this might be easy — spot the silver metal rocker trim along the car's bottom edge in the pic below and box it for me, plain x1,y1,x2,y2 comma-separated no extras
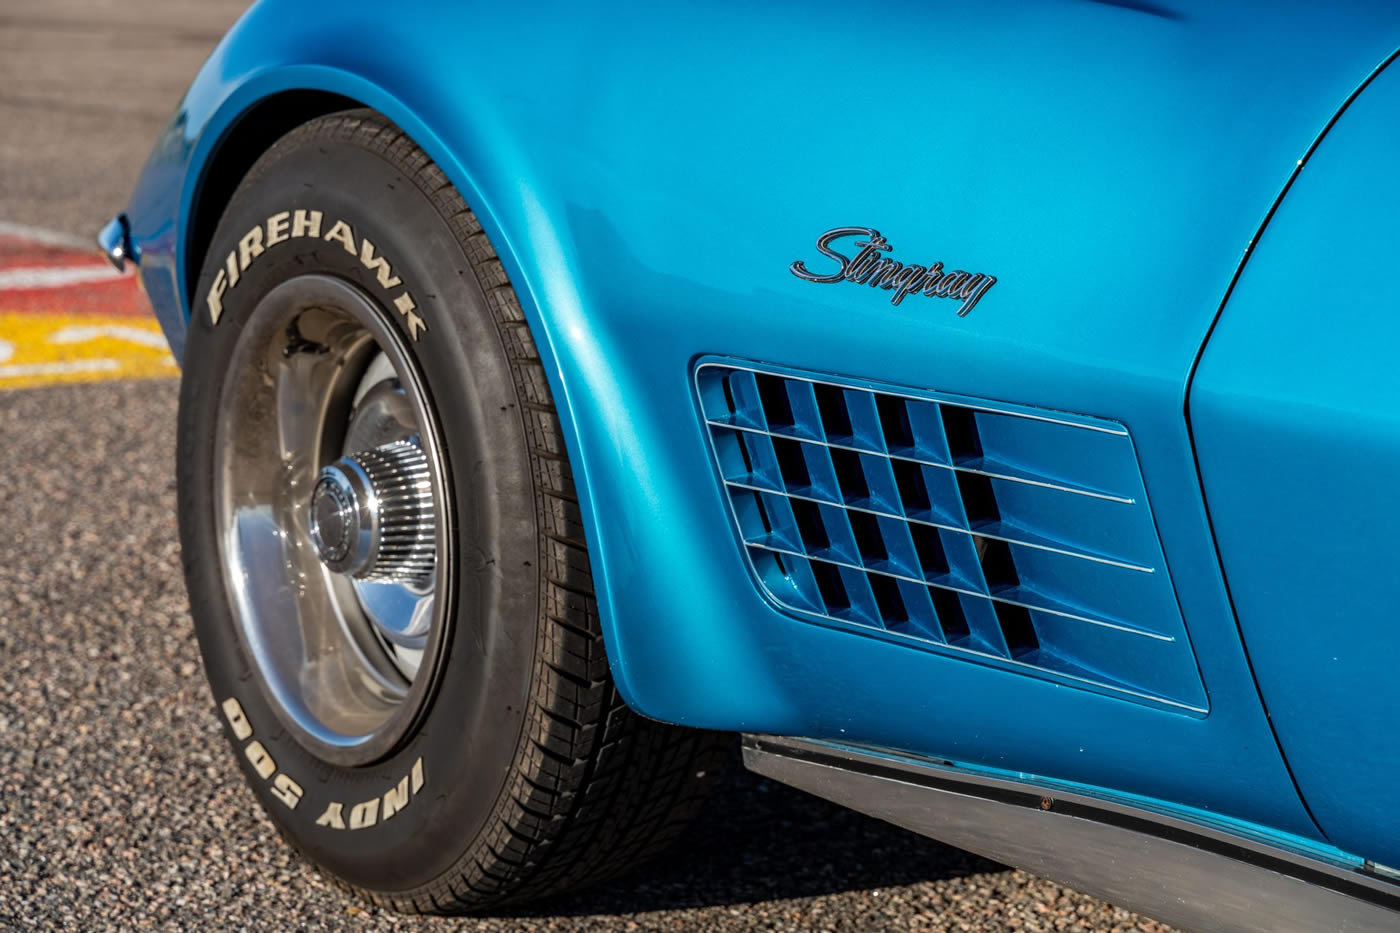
743,735,1400,933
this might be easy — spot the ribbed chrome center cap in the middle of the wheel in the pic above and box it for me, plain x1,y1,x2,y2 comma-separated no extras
308,441,435,584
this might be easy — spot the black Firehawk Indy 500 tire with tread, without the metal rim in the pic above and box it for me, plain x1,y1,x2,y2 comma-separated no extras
178,111,728,912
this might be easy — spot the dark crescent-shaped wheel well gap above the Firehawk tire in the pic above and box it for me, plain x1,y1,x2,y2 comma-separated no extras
185,91,364,307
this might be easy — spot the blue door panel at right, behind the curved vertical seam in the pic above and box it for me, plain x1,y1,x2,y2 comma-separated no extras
1190,49,1400,864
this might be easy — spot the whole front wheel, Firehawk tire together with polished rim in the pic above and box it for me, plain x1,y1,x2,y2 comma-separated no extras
179,111,724,912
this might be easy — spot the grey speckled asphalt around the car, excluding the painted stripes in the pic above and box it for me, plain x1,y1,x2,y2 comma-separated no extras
0,0,1166,933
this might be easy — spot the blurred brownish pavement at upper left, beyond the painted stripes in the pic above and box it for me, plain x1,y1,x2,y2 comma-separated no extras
0,0,248,237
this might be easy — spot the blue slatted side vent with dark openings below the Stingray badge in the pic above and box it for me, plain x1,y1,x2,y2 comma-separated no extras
696,361,1207,714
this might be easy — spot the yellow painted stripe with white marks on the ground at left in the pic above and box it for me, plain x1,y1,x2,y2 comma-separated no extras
0,314,179,389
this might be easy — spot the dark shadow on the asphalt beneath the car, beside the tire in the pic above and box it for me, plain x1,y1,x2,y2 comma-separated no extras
496,739,1007,918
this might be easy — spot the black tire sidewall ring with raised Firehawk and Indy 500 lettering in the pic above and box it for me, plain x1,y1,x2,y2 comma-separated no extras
178,121,539,891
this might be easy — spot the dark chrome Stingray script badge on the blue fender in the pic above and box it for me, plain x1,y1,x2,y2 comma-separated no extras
788,227,997,318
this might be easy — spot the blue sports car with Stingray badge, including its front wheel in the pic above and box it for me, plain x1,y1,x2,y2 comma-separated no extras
99,0,1400,930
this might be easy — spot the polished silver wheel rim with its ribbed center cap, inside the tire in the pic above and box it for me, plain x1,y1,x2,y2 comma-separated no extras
214,275,454,765
